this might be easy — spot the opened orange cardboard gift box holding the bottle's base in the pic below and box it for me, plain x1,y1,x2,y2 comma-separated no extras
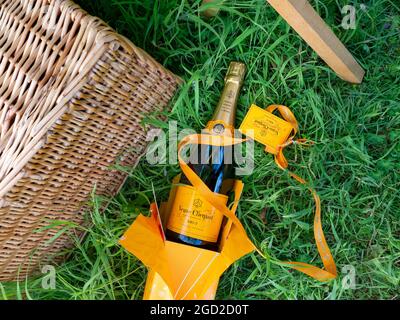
120,177,254,300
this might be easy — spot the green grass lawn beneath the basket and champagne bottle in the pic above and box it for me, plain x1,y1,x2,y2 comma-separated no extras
0,0,400,299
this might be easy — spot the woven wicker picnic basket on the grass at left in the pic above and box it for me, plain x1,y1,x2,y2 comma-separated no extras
0,0,179,281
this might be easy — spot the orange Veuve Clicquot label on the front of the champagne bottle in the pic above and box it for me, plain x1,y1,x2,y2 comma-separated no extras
167,186,228,242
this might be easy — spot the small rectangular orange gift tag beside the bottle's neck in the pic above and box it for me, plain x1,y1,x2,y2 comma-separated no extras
239,104,294,154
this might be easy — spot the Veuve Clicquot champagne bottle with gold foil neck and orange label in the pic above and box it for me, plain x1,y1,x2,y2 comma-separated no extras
166,62,246,249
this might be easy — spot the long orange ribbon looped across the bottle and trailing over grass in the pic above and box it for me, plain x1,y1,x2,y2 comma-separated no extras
178,111,337,281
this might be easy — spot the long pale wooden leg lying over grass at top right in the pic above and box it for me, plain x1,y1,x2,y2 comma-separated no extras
267,0,365,83
